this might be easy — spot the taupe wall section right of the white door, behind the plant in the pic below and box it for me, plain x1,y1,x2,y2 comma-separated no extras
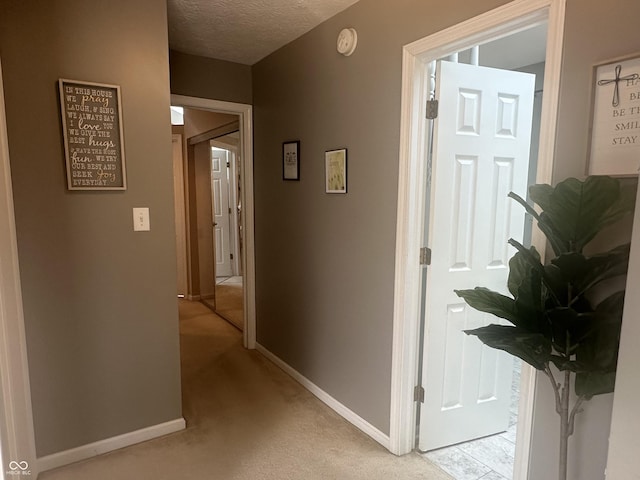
531,0,640,480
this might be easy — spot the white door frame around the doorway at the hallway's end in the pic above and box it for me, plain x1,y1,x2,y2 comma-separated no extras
171,95,256,349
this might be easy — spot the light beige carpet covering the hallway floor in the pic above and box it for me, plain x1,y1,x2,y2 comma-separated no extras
40,301,451,480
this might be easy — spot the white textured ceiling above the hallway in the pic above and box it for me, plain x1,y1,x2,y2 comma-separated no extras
167,0,358,65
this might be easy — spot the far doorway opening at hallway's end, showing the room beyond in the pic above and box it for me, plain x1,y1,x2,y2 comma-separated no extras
172,106,244,330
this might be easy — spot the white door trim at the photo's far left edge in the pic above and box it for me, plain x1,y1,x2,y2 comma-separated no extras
0,57,38,478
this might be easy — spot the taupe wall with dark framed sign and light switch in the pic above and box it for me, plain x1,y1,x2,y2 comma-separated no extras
0,0,181,456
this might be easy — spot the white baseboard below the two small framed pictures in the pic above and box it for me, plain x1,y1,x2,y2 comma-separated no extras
256,343,391,450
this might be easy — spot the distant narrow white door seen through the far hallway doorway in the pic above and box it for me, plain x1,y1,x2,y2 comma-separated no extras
211,147,232,277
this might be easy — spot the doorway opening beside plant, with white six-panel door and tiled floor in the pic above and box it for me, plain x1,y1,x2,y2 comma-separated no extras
417,27,547,480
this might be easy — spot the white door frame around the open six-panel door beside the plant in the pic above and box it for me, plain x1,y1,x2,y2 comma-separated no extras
389,0,565,479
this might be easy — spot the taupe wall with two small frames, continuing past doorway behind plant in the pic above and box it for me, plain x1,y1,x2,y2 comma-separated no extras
253,0,640,480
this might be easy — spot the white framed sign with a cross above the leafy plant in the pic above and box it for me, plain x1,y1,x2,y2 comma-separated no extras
588,57,640,176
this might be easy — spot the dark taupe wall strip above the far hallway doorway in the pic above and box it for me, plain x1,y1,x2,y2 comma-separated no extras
169,50,252,104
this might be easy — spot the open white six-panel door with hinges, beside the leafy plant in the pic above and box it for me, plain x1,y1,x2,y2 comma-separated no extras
418,62,535,451
